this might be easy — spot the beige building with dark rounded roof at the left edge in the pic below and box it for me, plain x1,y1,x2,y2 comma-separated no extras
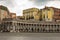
0,5,9,22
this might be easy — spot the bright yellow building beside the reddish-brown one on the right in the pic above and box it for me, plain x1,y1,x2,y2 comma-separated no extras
42,7,54,21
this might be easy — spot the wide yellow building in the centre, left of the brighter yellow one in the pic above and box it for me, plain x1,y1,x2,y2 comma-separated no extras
23,8,40,20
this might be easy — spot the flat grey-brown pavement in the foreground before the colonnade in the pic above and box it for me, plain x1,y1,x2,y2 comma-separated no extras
0,33,60,40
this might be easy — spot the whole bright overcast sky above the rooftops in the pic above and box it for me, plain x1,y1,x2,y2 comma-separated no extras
0,0,60,16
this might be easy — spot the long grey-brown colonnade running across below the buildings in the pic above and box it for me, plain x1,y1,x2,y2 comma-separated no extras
0,22,60,32
